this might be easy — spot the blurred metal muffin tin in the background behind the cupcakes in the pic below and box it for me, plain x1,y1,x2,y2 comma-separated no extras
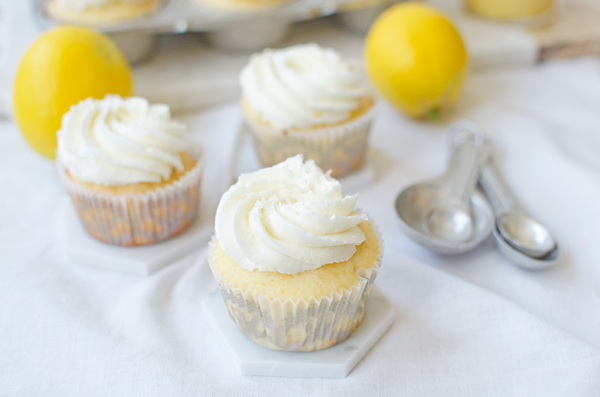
32,0,396,58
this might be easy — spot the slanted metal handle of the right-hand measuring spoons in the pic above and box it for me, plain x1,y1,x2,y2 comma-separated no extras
479,160,523,215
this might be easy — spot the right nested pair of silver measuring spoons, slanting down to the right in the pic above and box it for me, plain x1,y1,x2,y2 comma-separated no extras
479,161,560,269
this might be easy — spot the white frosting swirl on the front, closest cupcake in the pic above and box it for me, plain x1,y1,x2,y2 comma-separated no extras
215,155,367,274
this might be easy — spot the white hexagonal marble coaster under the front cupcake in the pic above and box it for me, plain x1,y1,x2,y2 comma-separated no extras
202,287,396,378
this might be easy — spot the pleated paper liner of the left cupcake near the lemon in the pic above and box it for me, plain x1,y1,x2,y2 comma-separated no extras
56,146,204,246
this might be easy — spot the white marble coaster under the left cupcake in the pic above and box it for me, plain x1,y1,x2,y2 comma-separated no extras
63,197,214,276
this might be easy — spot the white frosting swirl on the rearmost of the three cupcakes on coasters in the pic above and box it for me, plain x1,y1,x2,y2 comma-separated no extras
240,44,369,128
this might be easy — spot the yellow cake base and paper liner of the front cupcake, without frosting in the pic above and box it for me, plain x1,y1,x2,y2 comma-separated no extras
208,218,383,351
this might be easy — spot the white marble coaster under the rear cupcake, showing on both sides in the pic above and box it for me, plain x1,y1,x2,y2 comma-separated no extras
231,125,375,194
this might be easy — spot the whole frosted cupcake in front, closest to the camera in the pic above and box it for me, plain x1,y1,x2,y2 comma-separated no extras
208,155,383,351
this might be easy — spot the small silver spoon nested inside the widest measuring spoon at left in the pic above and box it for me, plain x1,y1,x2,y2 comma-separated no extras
425,122,488,243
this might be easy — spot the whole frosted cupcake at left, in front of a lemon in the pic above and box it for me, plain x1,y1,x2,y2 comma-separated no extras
57,95,202,246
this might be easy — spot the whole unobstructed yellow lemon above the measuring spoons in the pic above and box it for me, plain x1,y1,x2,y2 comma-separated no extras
365,2,468,118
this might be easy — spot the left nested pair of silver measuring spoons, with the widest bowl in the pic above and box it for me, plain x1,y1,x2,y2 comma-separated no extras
395,121,492,254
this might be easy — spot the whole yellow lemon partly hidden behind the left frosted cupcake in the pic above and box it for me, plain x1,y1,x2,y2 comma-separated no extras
13,26,133,158
